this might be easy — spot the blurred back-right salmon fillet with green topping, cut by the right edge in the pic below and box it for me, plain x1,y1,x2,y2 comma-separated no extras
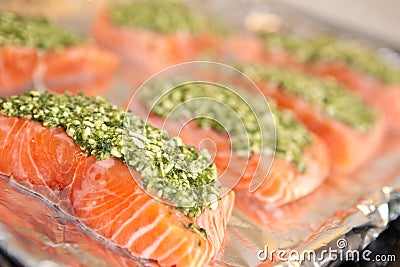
256,34,400,134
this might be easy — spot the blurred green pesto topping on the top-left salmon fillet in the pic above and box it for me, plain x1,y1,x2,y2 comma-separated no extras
0,11,84,50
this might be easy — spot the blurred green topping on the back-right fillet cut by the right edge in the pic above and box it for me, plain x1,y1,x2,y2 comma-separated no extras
264,34,400,84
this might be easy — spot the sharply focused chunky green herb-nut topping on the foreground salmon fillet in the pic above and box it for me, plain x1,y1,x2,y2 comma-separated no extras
0,91,219,217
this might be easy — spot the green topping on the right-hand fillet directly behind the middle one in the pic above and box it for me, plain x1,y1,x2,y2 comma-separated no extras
241,66,377,133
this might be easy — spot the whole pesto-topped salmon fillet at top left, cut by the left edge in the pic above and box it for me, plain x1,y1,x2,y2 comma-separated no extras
0,11,117,97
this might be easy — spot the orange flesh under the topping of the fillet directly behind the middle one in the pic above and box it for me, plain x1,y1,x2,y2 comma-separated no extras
259,82,386,173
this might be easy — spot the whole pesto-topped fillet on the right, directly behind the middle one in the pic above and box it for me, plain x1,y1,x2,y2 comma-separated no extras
242,65,386,174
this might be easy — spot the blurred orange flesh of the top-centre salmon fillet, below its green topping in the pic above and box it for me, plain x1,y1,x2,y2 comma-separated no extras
92,1,222,85
